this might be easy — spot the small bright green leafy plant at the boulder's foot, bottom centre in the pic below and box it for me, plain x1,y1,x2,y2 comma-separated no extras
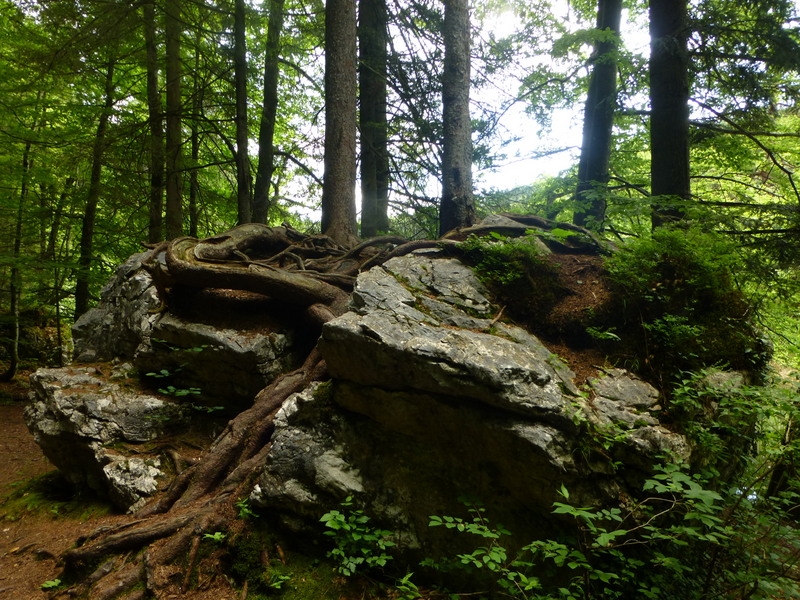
320,496,395,576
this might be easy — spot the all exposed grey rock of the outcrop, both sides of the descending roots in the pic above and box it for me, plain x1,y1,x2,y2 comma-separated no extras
27,243,689,540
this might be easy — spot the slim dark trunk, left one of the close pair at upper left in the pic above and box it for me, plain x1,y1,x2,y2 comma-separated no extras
142,2,164,243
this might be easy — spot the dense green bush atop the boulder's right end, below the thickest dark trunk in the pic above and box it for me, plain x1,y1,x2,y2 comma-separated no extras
606,228,770,383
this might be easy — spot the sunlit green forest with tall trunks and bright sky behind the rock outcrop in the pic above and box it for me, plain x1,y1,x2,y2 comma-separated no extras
0,0,800,598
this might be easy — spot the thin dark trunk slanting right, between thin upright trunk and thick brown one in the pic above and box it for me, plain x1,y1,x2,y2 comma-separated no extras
253,0,284,223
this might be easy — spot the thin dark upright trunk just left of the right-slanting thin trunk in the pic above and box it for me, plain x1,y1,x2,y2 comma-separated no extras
233,0,252,225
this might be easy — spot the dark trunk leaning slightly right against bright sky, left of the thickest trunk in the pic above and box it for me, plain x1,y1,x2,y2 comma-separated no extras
573,0,622,230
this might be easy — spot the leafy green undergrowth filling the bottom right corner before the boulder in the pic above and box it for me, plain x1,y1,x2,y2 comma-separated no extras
418,464,800,600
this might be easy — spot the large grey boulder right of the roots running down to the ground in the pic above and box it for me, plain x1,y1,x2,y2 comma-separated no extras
252,256,689,552
